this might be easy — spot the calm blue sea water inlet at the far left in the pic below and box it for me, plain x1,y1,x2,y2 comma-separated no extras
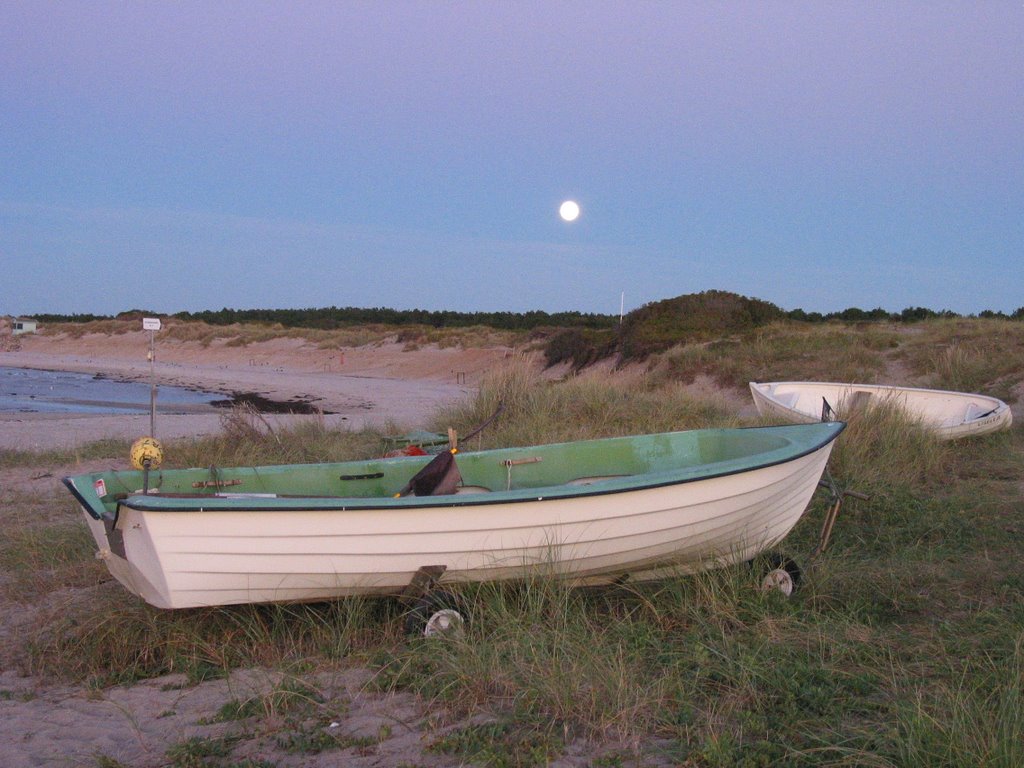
0,367,224,414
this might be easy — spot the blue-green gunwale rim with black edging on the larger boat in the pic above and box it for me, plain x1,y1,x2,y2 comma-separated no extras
79,421,846,519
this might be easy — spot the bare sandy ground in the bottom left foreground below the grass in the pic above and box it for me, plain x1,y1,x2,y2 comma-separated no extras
0,670,452,768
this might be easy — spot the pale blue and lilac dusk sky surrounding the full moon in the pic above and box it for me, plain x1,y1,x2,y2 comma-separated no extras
0,0,1024,314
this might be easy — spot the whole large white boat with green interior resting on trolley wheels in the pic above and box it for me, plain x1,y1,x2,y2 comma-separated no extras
65,422,845,608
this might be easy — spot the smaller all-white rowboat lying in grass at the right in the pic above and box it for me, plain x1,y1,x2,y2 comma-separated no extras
751,381,1013,440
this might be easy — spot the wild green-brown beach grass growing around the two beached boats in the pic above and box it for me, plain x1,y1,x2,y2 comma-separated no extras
0,321,1024,768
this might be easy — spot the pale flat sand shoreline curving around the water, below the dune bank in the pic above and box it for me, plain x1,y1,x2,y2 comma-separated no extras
0,348,487,451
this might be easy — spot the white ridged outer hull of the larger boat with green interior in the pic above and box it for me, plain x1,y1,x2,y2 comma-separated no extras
66,424,843,608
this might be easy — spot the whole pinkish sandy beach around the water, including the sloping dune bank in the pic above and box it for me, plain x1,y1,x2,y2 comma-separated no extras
0,332,512,450
